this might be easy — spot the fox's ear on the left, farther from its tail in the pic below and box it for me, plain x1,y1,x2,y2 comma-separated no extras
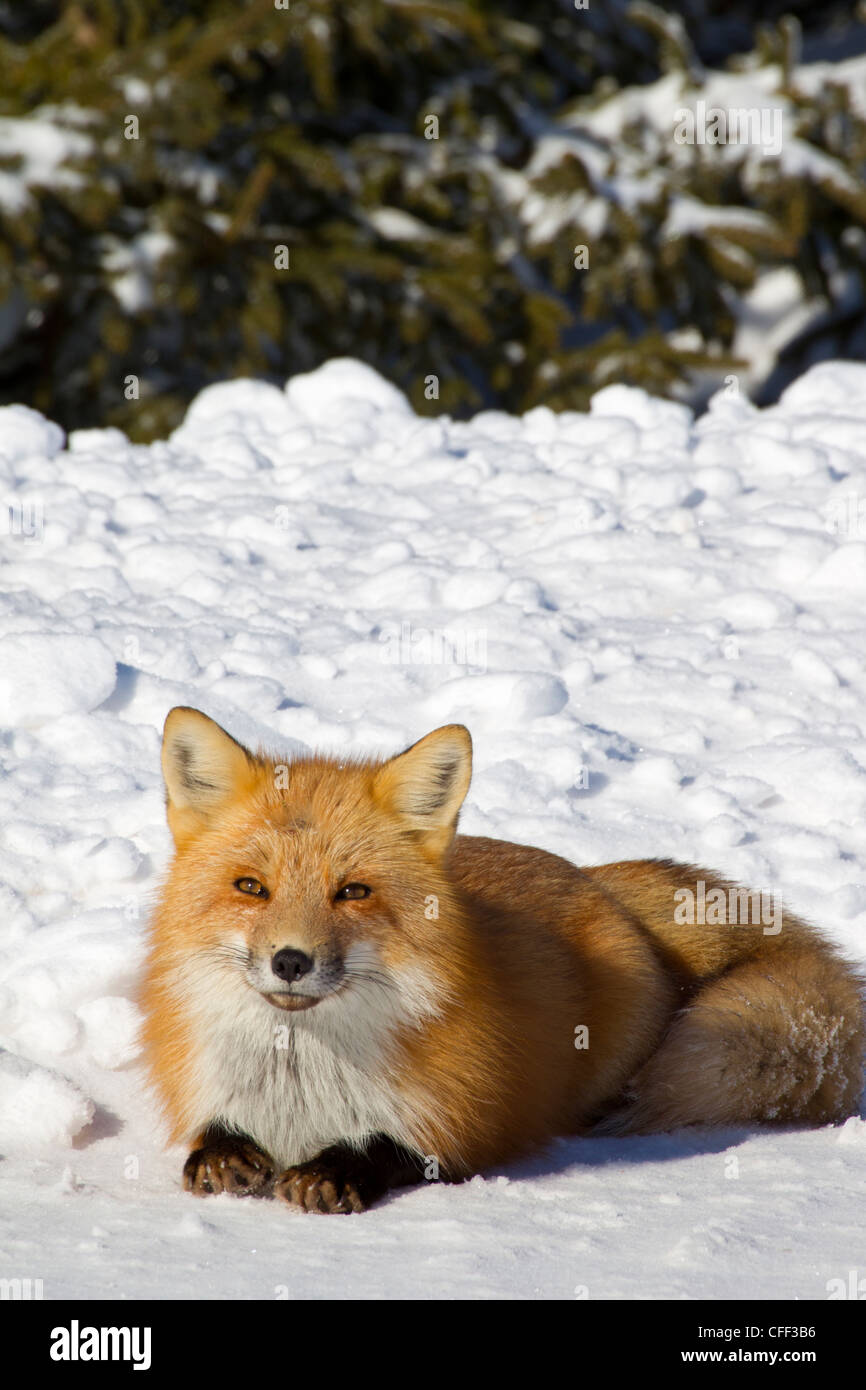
163,705,256,847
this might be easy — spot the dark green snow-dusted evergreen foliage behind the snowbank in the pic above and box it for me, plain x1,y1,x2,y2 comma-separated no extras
0,0,866,438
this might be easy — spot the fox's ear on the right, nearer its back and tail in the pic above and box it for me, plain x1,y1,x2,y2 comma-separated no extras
374,724,473,855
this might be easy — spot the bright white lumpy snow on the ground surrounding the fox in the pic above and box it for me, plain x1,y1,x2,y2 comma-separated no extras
0,360,866,1298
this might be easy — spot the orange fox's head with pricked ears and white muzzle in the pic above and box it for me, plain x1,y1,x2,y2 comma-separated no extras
157,708,471,1015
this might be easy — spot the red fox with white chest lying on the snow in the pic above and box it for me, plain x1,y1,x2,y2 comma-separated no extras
142,708,865,1212
